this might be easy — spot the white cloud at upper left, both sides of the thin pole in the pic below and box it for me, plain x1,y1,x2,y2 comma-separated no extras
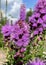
1,0,22,20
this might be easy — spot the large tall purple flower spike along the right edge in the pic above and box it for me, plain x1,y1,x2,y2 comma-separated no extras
29,0,46,35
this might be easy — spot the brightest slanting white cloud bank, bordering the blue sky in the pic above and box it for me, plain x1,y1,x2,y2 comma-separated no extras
8,0,22,18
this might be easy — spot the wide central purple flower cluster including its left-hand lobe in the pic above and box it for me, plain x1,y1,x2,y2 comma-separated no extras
2,20,30,47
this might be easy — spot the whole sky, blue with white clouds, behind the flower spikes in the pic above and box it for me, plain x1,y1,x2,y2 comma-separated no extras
1,0,37,20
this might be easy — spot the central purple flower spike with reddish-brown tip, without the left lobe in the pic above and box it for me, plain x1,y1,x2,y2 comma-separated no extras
12,20,30,47
